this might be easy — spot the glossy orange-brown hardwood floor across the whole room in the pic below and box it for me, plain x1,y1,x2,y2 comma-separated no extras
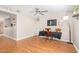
0,36,76,53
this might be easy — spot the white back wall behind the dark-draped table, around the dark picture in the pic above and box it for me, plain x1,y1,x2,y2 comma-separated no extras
38,12,70,41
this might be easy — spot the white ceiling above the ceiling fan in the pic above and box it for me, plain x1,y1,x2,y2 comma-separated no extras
0,5,72,14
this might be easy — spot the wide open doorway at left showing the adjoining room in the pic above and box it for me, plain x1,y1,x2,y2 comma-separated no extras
0,11,17,39
